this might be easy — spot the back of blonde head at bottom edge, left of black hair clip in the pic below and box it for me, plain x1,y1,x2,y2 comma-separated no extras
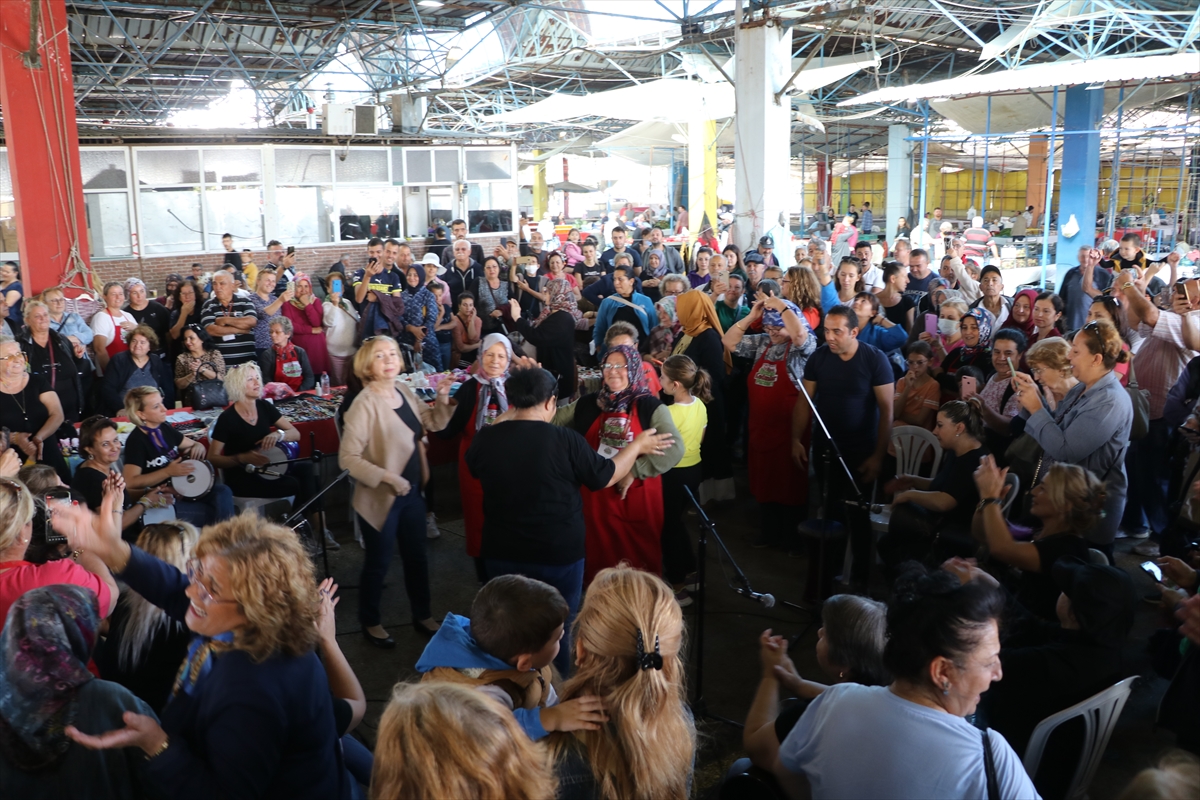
371,684,554,800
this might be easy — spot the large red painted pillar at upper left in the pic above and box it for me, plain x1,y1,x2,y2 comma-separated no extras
0,0,90,294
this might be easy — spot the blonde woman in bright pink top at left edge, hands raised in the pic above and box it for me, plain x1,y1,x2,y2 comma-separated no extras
0,477,121,620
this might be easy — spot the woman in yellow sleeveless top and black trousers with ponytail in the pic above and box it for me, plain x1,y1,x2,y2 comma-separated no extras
659,357,713,606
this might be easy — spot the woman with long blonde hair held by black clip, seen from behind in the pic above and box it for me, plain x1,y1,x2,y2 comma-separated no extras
550,565,696,800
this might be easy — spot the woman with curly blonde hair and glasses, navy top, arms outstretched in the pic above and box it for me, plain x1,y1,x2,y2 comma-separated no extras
53,504,349,800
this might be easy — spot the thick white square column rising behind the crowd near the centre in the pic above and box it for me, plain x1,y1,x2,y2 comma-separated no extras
734,19,792,249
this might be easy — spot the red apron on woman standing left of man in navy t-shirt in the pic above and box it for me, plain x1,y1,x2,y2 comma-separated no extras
746,345,811,506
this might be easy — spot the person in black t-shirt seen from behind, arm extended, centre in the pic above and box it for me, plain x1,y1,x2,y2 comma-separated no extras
467,367,672,669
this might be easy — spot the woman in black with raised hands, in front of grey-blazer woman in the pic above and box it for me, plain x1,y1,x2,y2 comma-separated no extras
974,457,1106,621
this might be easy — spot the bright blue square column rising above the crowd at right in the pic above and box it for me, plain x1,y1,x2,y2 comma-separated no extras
1055,86,1104,256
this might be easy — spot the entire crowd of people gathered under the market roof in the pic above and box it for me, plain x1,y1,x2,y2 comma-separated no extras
0,209,1200,798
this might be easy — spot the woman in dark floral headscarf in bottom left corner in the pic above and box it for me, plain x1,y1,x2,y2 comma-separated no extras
0,584,155,799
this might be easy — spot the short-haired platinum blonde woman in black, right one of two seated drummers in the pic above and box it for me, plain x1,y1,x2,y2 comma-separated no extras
209,363,325,536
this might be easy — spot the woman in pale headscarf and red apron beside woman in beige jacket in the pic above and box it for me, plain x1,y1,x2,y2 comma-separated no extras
438,333,514,583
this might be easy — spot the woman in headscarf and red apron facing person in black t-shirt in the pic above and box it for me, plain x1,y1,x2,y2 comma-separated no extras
554,344,684,587
